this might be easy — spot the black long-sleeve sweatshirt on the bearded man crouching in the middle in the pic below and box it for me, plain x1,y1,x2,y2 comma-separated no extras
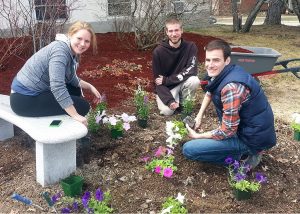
152,39,198,106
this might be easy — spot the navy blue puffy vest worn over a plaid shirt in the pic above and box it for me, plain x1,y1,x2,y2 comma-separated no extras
206,65,276,153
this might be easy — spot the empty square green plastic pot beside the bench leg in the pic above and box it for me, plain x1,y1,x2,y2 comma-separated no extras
60,175,83,197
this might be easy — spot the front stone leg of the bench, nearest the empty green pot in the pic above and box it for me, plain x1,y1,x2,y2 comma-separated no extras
36,140,76,187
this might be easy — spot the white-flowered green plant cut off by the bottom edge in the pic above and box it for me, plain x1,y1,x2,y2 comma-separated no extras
161,193,188,214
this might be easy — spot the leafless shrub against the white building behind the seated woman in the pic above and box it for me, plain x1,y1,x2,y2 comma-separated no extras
0,0,78,52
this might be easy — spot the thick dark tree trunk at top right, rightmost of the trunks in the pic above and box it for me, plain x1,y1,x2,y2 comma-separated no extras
264,0,284,25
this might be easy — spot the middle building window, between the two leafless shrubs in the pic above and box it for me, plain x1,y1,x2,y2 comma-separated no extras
107,0,131,16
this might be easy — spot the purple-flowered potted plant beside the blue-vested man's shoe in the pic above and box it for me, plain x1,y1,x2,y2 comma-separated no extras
225,157,267,192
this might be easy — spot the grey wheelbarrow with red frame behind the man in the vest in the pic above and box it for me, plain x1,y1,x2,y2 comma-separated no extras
200,46,300,89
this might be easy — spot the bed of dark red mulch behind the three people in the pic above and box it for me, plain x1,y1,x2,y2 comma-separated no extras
0,33,214,107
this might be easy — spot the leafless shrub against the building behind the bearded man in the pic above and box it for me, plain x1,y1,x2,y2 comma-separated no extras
97,0,210,50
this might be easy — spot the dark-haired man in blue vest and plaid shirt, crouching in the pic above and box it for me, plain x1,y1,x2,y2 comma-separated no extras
183,40,276,168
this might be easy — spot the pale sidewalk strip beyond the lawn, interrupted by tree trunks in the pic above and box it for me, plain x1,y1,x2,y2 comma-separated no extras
215,15,300,26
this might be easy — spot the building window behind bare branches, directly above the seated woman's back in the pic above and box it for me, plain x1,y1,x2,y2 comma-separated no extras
34,0,68,21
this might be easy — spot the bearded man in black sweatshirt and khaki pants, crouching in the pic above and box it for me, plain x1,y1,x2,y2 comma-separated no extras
152,19,200,115
